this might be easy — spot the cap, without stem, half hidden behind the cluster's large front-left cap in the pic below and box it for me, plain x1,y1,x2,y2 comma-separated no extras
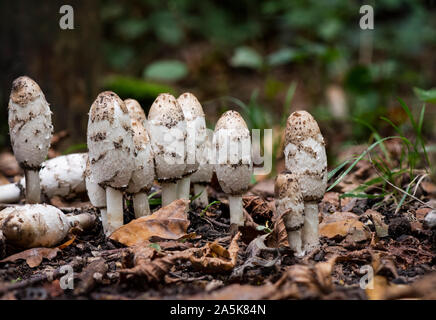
124,99,155,193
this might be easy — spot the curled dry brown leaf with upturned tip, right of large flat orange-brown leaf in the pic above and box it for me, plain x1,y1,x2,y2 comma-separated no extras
189,232,241,273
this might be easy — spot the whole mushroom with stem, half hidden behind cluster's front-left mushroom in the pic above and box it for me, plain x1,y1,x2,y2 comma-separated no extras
124,99,155,218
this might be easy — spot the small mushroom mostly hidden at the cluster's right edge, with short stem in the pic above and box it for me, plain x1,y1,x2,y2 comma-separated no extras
191,129,214,208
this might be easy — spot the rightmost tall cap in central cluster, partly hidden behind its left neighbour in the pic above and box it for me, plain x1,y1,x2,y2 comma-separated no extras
177,92,206,174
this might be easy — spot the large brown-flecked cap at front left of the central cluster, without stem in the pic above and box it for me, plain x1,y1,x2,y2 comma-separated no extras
87,91,135,189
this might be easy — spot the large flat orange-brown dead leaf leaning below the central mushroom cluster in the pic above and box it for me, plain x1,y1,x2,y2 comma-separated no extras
110,199,189,246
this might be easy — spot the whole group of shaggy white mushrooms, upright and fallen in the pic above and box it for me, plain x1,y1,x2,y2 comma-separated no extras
0,76,327,256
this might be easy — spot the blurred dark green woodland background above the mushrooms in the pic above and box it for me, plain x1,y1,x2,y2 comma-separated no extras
0,0,436,175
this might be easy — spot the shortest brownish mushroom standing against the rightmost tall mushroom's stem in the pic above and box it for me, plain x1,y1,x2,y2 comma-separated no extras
274,171,304,257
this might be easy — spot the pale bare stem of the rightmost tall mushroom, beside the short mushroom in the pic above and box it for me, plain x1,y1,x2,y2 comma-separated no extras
302,202,319,252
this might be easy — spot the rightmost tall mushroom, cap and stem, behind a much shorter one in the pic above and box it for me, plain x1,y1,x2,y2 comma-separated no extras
284,111,327,253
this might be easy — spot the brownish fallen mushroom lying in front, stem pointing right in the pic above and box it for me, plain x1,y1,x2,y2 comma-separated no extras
0,204,95,248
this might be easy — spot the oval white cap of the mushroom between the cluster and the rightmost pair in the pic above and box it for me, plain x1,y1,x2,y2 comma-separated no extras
213,110,253,195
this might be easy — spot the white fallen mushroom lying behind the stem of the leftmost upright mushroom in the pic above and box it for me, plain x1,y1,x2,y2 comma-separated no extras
0,153,88,203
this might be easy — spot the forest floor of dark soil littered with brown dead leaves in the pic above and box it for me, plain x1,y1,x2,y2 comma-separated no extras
0,140,436,300
